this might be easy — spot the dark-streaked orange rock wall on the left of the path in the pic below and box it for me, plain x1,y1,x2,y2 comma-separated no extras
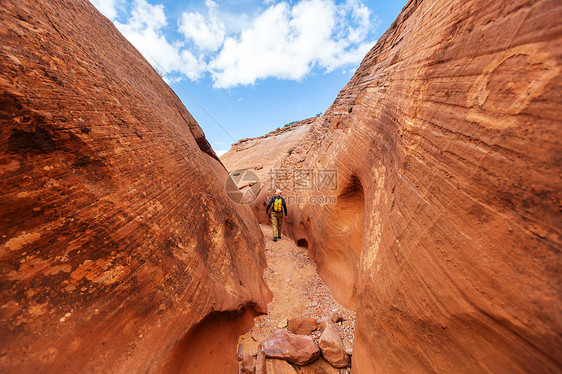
0,0,270,373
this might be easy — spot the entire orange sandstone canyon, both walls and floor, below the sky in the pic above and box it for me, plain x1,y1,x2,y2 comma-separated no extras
0,0,562,374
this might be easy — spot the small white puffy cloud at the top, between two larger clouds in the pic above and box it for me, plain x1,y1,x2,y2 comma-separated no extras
178,0,226,51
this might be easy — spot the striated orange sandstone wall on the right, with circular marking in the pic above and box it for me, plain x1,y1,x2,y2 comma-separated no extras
223,0,562,374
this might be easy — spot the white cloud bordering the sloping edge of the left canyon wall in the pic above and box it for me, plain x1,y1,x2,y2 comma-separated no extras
114,0,206,80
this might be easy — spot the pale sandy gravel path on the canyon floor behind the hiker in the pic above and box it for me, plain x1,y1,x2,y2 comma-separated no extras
239,225,355,353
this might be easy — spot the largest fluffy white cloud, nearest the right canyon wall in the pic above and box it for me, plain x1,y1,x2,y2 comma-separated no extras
209,0,373,88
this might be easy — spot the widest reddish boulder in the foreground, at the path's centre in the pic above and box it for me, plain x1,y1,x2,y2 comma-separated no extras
260,330,320,365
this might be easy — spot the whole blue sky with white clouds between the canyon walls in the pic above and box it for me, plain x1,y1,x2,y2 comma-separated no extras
90,0,407,154
